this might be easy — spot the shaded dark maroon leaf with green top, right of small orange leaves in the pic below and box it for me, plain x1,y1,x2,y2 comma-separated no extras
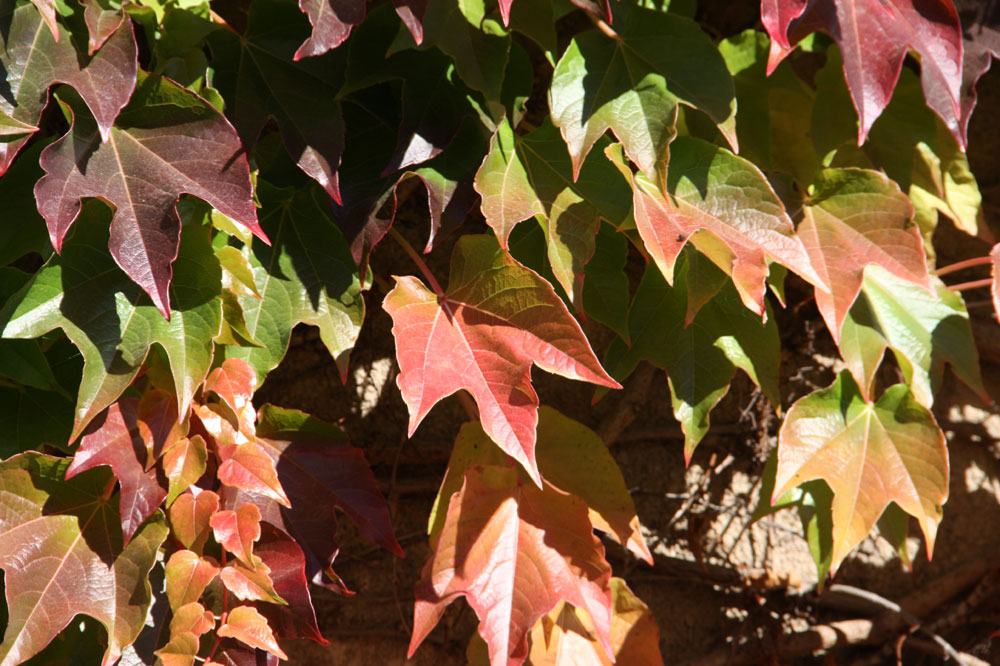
257,405,403,584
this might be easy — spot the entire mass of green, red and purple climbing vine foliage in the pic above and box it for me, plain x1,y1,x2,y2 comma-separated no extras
0,0,1000,666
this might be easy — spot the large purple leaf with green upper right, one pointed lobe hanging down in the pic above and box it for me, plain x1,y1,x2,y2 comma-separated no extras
35,70,267,318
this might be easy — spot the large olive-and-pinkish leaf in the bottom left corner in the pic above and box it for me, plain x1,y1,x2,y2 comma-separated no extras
0,452,167,666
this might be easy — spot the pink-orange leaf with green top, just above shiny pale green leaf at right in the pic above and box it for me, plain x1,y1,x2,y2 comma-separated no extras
798,169,933,341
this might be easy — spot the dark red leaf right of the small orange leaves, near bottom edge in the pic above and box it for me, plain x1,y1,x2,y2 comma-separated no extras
256,523,329,645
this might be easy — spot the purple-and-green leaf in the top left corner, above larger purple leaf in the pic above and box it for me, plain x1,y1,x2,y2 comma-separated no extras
0,2,138,175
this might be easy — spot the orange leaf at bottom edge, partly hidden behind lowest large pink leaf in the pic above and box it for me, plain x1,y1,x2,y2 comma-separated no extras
528,578,663,666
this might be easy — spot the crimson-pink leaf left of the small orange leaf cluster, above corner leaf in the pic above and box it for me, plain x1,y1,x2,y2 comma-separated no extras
66,399,167,545
